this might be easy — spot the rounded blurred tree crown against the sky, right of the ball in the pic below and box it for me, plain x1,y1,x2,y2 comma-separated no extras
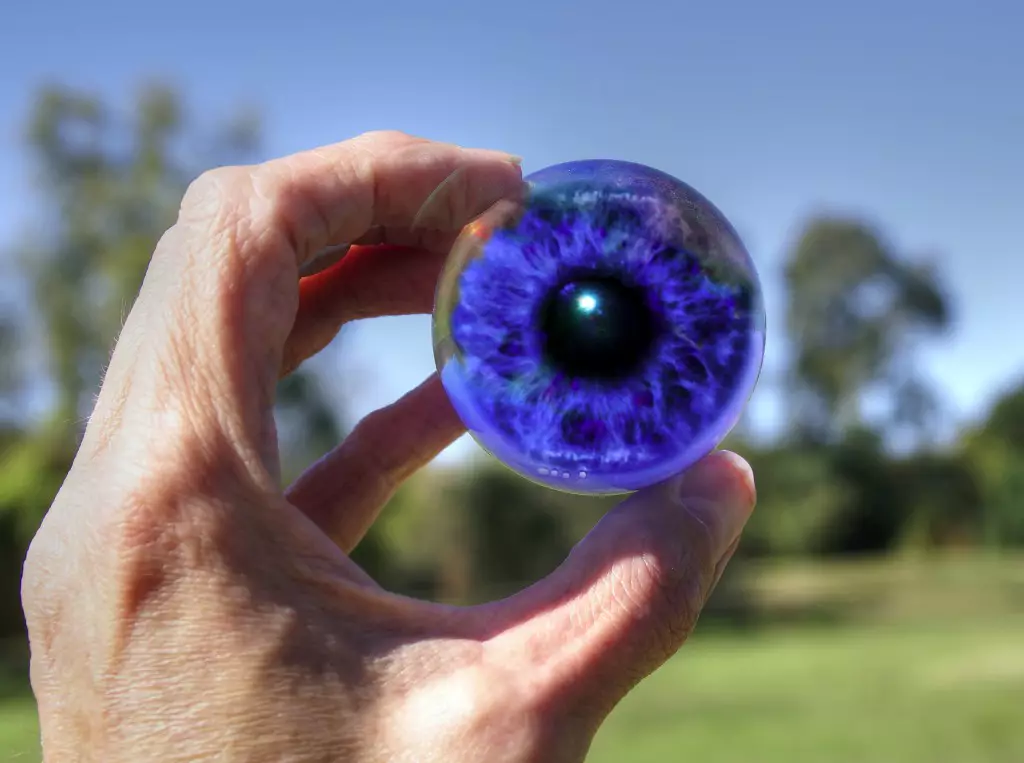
785,217,950,442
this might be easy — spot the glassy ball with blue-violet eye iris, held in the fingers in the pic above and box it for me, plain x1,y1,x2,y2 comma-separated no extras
433,161,765,494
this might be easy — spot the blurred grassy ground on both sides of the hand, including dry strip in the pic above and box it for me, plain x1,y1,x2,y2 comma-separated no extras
0,559,1024,763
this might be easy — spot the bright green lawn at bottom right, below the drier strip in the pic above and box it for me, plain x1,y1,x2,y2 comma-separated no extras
588,620,1024,763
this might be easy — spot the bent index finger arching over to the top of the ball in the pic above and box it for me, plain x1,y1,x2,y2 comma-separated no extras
87,132,522,461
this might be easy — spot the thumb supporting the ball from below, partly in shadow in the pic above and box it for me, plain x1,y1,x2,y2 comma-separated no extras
491,451,756,718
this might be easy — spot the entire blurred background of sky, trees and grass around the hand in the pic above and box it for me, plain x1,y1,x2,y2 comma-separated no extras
0,0,1024,763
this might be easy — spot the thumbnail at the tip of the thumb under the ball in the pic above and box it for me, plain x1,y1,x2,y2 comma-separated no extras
676,451,757,559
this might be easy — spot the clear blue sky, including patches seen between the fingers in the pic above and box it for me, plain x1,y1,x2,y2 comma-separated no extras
0,0,1024,458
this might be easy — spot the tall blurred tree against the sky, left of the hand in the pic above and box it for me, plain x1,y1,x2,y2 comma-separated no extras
22,84,258,432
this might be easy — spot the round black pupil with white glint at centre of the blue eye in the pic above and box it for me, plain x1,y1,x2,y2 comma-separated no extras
540,278,656,379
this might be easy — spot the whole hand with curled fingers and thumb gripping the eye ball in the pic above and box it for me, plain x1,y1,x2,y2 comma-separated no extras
23,133,754,763
